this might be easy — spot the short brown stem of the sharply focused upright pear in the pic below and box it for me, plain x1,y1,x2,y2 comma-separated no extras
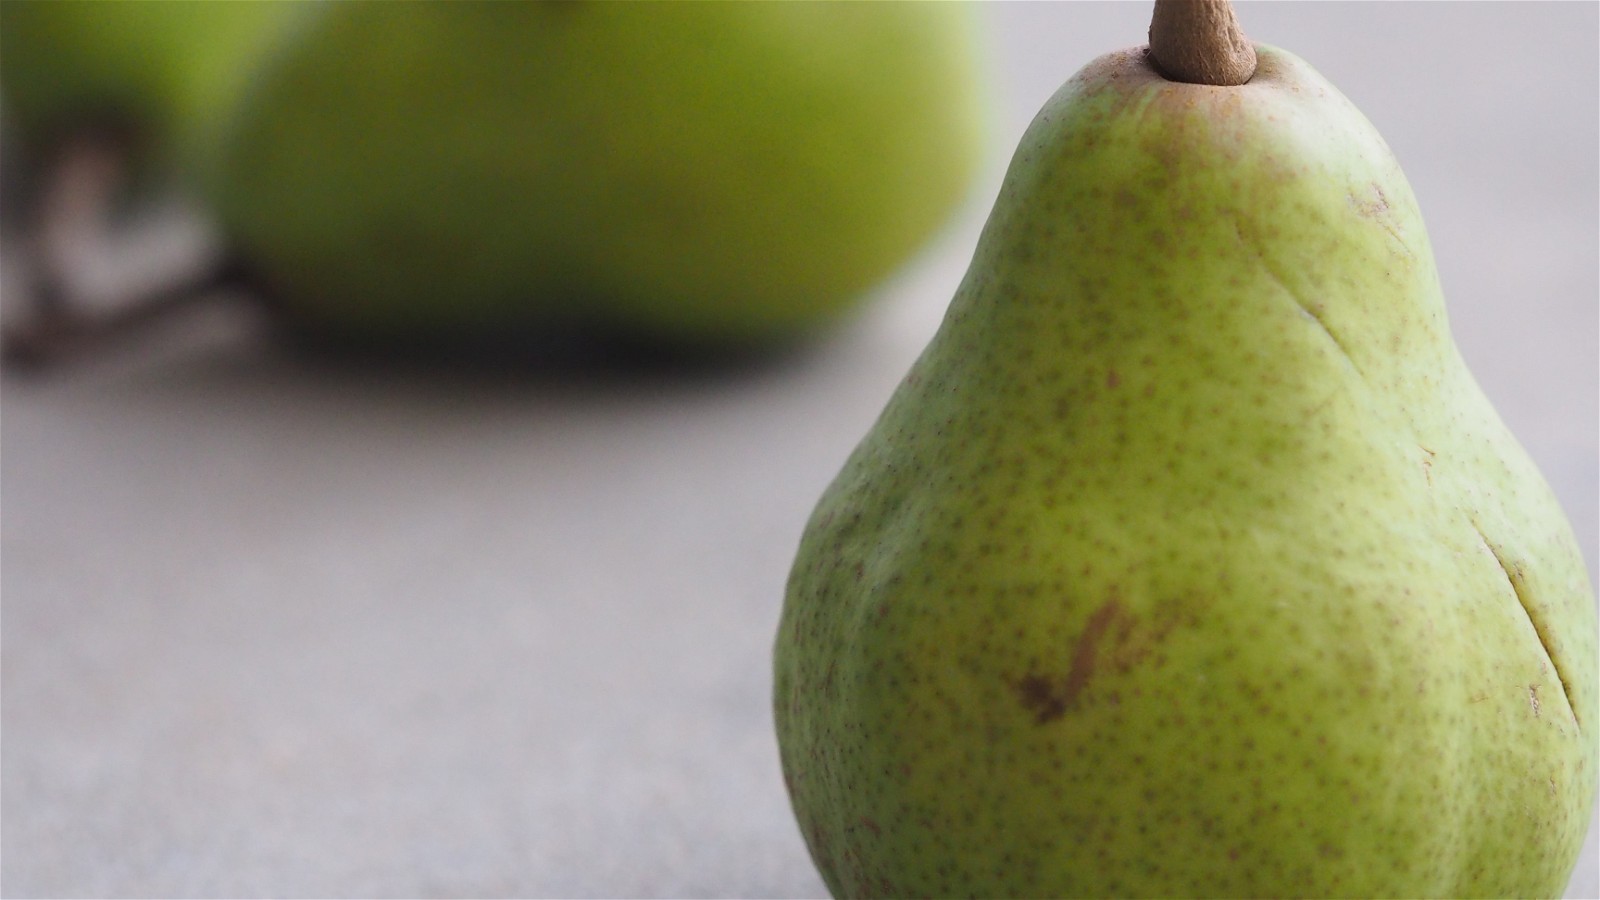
1150,0,1256,86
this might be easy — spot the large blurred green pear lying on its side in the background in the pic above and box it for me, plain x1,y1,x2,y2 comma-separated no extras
208,3,986,344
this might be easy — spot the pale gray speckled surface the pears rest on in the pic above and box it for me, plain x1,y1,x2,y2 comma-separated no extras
0,3,1600,897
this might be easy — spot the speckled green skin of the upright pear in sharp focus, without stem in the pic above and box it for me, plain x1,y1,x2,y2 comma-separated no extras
774,45,1597,897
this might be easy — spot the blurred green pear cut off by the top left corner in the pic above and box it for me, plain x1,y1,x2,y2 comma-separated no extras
0,0,302,171
